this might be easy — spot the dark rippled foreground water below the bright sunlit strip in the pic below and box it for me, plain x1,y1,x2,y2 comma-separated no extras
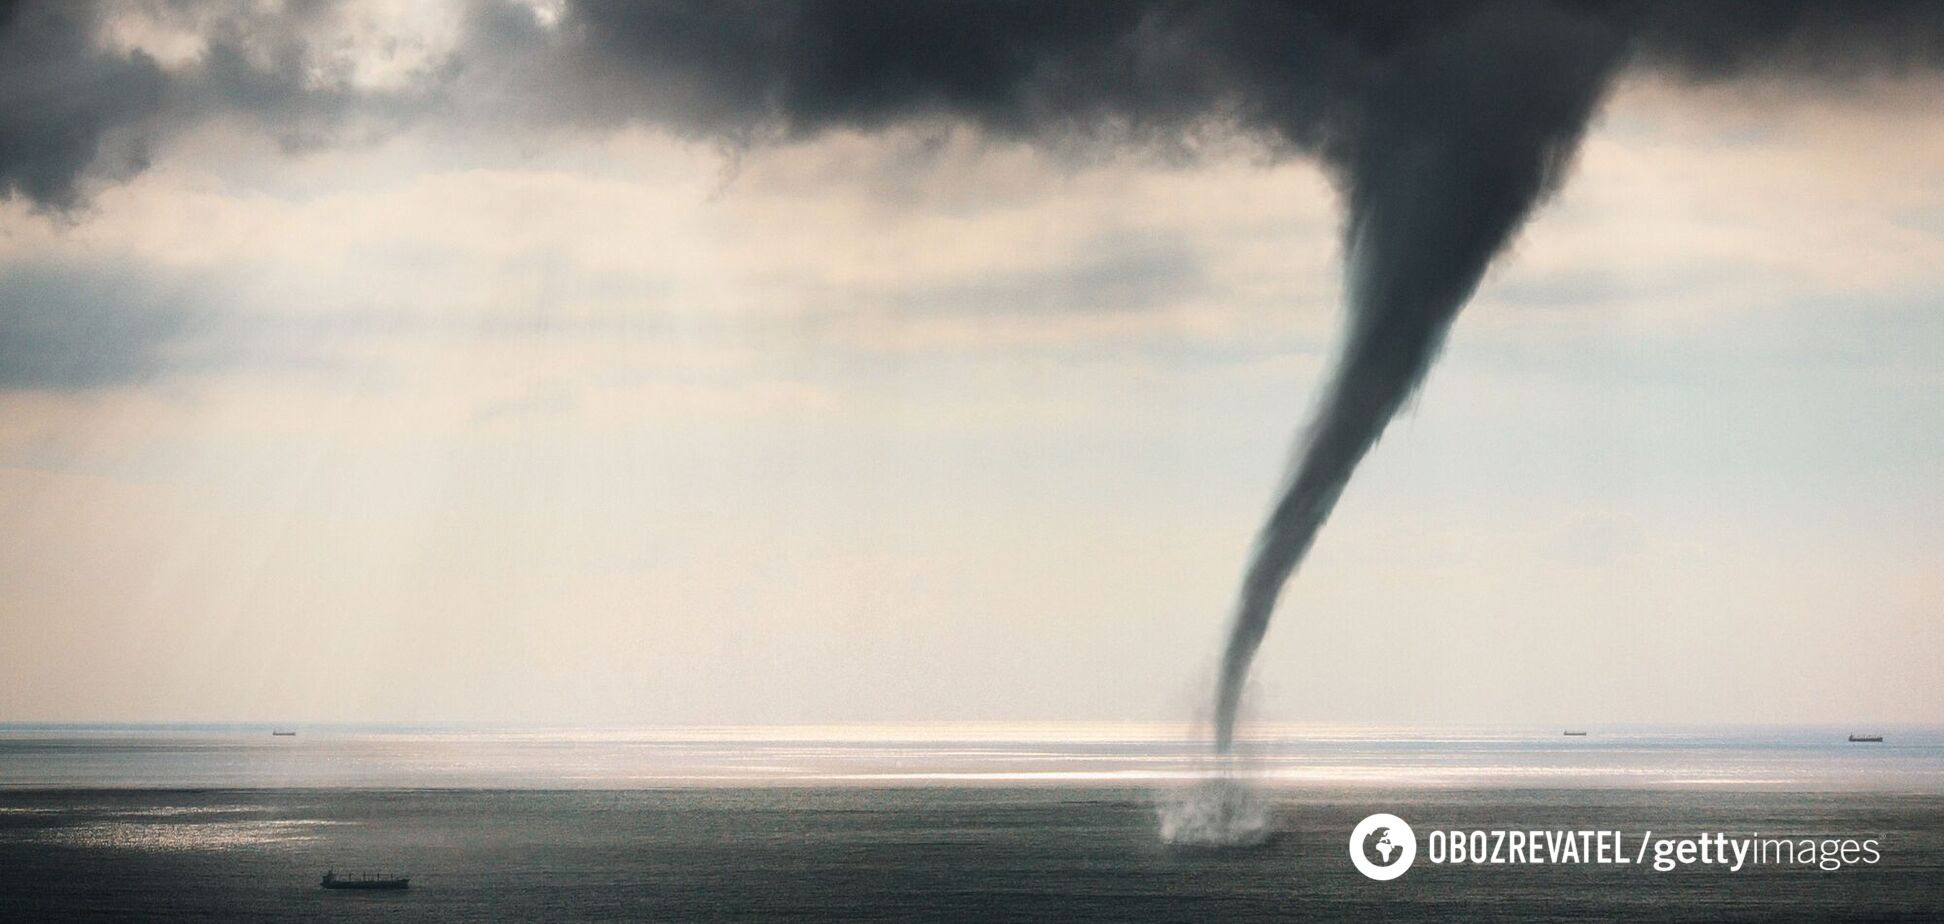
0,786,1944,922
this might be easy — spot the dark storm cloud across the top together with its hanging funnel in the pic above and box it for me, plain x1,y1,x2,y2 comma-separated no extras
11,0,1944,749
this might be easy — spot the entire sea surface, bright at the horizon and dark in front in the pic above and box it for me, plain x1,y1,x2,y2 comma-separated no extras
0,726,1944,922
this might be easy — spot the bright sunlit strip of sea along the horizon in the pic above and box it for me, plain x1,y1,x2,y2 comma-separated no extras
0,726,1944,793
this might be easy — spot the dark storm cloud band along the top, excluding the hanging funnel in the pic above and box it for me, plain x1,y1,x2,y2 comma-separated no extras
11,0,1944,210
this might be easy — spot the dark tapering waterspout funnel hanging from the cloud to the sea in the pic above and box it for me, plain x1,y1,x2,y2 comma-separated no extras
1215,8,1619,749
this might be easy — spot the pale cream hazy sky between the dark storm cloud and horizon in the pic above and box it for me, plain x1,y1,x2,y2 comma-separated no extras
0,4,1944,726
